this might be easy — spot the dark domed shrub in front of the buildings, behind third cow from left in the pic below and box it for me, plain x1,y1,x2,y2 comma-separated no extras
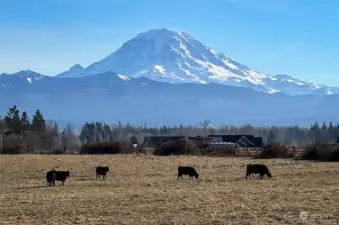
154,140,200,156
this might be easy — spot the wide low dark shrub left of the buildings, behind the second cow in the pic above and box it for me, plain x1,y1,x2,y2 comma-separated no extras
80,141,122,154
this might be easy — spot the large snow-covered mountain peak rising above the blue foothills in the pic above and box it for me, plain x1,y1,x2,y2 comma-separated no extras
57,28,339,95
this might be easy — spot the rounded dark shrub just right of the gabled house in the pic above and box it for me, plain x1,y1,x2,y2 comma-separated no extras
256,142,289,159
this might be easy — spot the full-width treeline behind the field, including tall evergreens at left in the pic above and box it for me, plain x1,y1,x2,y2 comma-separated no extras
0,106,339,155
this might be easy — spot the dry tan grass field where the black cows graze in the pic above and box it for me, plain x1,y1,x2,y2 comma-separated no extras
0,155,339,225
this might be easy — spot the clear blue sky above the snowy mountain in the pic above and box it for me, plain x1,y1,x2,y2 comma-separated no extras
0,0,339,86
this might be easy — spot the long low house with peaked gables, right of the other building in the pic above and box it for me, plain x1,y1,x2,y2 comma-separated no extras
208,134,264,148
